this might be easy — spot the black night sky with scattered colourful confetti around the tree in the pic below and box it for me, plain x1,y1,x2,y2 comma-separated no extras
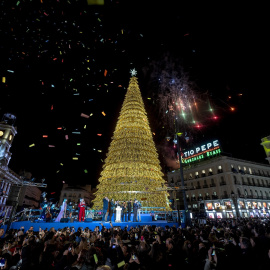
0,0,270,200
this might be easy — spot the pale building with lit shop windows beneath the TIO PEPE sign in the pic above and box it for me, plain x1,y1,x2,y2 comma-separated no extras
167,156,270,218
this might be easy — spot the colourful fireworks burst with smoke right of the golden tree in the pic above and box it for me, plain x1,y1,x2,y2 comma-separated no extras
144,53,218,168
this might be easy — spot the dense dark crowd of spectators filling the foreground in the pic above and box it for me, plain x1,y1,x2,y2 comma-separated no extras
0,218,270,270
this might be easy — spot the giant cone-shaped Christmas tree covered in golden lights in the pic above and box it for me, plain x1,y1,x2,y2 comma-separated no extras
93,77,170,210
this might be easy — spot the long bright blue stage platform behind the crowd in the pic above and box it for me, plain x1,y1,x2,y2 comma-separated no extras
10,220,179,231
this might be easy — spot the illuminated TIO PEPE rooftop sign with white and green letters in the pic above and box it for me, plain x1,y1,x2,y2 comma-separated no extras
182,140,221,163
